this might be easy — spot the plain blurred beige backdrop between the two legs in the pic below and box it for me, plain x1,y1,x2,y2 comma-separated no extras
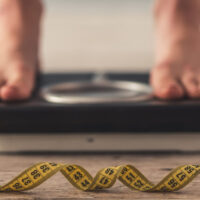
41,0,154,72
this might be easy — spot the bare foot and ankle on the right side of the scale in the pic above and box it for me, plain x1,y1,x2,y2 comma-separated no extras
151,0,200,99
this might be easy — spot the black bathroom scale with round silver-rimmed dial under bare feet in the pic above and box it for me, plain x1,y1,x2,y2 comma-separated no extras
0,73,200,152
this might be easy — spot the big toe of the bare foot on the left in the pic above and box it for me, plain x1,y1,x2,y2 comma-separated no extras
0,64,34,101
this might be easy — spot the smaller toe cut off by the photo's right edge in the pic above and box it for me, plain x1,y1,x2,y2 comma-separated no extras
182,74,200,99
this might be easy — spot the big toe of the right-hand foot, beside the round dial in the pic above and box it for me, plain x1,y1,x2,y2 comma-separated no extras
151,65,184,100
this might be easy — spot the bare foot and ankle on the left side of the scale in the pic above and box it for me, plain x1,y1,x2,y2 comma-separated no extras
0,0,42,101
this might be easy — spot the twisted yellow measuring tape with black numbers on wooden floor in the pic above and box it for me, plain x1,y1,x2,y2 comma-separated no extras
0,162,200,192
